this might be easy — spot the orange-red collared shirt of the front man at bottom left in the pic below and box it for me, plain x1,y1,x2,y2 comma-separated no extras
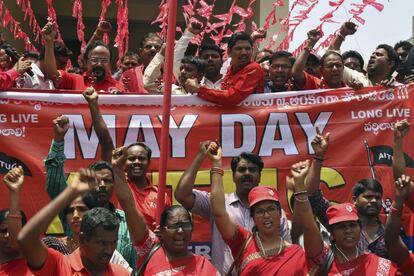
31,248,131,276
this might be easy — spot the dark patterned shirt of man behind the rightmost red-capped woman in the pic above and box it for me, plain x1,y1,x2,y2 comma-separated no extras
309,190,387,257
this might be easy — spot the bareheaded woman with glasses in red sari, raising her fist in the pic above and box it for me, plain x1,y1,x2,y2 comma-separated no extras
112,147,219,276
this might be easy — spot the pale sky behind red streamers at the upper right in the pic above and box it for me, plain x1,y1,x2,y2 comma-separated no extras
288,0,414,62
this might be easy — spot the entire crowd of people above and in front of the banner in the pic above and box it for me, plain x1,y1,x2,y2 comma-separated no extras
0,15,414,276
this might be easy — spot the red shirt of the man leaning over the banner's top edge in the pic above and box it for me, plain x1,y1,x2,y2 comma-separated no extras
198,62,264,106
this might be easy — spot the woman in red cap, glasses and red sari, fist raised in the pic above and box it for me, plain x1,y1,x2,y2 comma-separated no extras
208,142,308,275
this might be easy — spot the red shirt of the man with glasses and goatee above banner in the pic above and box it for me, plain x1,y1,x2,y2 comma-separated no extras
56,70,125,92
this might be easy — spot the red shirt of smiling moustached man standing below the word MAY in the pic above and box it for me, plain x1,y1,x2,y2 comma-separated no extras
113,177,171,231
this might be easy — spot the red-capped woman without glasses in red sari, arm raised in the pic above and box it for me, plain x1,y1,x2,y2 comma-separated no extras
291,161,400,276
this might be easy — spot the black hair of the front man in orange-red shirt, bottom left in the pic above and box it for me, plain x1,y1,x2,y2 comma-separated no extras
80,207,119,239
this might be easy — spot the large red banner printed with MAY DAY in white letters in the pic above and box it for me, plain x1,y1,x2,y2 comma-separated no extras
0,86,414,254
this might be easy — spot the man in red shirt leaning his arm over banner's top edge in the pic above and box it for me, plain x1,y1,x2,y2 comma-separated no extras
185,32,264,106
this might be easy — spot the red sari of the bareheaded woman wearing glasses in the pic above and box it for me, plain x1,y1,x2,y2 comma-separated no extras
135,231,220,276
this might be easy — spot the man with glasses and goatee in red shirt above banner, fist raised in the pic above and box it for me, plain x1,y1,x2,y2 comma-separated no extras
42,22,124,94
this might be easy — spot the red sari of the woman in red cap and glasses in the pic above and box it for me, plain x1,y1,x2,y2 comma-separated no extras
225,225,309,275
